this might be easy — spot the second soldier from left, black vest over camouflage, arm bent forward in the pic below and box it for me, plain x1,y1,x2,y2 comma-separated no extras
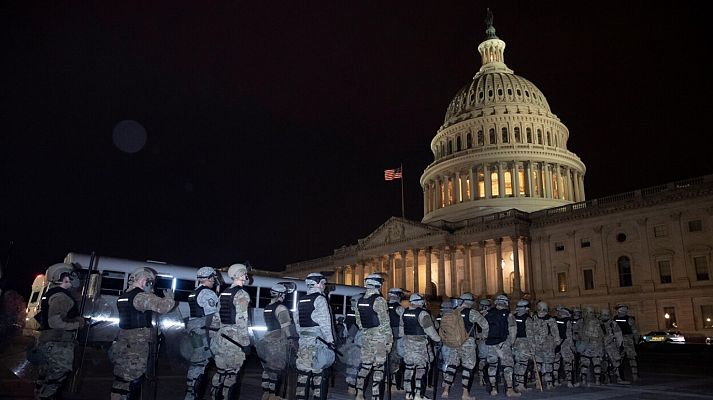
111,268,176,400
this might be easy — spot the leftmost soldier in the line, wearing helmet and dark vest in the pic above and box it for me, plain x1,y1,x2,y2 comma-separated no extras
35,264,84,399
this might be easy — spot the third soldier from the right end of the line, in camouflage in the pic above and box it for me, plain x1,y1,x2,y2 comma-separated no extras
578,306,604,385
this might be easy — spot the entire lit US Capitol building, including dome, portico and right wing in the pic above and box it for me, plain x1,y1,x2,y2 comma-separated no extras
284,13,713,336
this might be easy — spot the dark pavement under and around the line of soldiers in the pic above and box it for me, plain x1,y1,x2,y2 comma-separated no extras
0,338,713,400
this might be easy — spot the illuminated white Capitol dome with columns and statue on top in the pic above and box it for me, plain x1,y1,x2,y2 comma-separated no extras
421,11,586,223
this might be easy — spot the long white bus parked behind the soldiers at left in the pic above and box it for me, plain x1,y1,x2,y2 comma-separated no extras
23,253,366,354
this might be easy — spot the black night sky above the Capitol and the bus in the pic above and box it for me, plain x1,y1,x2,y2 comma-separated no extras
0,0,713,295
